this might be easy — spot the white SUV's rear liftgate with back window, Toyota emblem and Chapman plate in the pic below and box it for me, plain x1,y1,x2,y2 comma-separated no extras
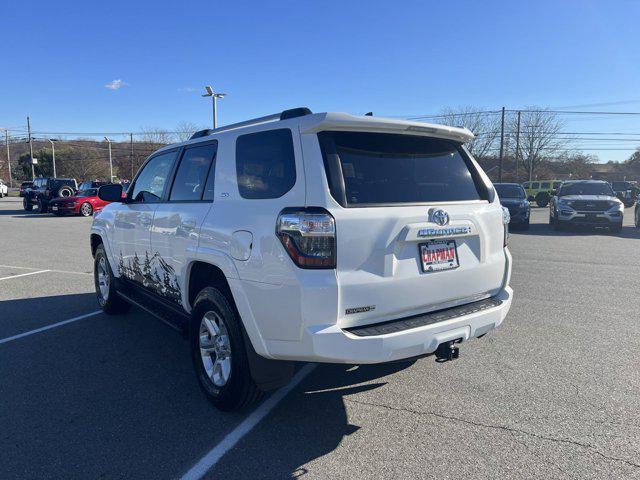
319,132,505,327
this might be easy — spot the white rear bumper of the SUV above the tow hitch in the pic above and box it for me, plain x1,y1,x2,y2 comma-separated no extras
267,287,513,364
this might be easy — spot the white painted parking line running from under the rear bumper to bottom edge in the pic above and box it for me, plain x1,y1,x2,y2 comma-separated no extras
180,363,316,480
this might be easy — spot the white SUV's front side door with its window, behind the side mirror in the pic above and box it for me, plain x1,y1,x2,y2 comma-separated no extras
112,150,178,286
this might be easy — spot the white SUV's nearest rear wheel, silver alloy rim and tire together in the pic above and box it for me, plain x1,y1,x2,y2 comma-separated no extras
190,287,262,411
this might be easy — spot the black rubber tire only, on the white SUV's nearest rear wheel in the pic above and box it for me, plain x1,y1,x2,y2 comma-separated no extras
189,287,262,411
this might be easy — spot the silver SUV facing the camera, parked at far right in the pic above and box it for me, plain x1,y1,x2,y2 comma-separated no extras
549,180,624,232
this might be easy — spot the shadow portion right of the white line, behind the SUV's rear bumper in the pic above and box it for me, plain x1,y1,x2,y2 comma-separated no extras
207,360,415,479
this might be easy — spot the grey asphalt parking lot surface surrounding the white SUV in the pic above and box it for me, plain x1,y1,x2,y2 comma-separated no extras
0,198,640,479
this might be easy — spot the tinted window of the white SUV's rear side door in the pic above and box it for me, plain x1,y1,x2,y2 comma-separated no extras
169,144,216,201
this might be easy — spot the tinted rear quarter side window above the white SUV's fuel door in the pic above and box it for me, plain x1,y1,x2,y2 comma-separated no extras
236,129,296,198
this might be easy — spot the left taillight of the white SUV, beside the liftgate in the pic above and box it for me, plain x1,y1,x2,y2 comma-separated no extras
276,208,336,268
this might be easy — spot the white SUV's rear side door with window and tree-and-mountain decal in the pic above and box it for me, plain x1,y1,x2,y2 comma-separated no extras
150,141,217,303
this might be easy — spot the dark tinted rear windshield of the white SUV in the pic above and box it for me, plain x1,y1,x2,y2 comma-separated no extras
318,132,486,206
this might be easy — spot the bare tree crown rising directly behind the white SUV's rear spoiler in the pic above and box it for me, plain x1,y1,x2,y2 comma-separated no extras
437,106,500,158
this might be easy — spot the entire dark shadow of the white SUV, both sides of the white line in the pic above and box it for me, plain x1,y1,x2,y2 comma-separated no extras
0,293,418,479
